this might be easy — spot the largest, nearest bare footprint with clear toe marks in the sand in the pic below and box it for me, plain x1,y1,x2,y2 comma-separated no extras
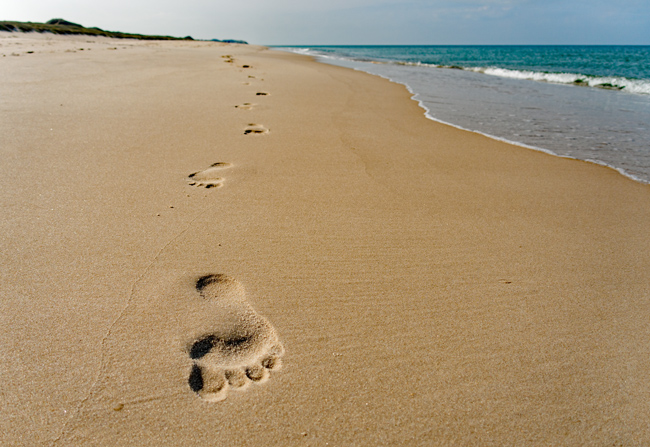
187,274,284,402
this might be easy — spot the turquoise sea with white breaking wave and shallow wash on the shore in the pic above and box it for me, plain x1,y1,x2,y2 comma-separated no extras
275,45,650,183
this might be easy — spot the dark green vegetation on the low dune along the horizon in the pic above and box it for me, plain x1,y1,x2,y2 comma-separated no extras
0,19,194,40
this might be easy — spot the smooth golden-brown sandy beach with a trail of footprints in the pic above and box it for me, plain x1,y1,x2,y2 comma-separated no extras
0,33,650,446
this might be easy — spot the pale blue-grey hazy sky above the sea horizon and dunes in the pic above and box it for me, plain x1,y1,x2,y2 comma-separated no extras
5,0,650,45
